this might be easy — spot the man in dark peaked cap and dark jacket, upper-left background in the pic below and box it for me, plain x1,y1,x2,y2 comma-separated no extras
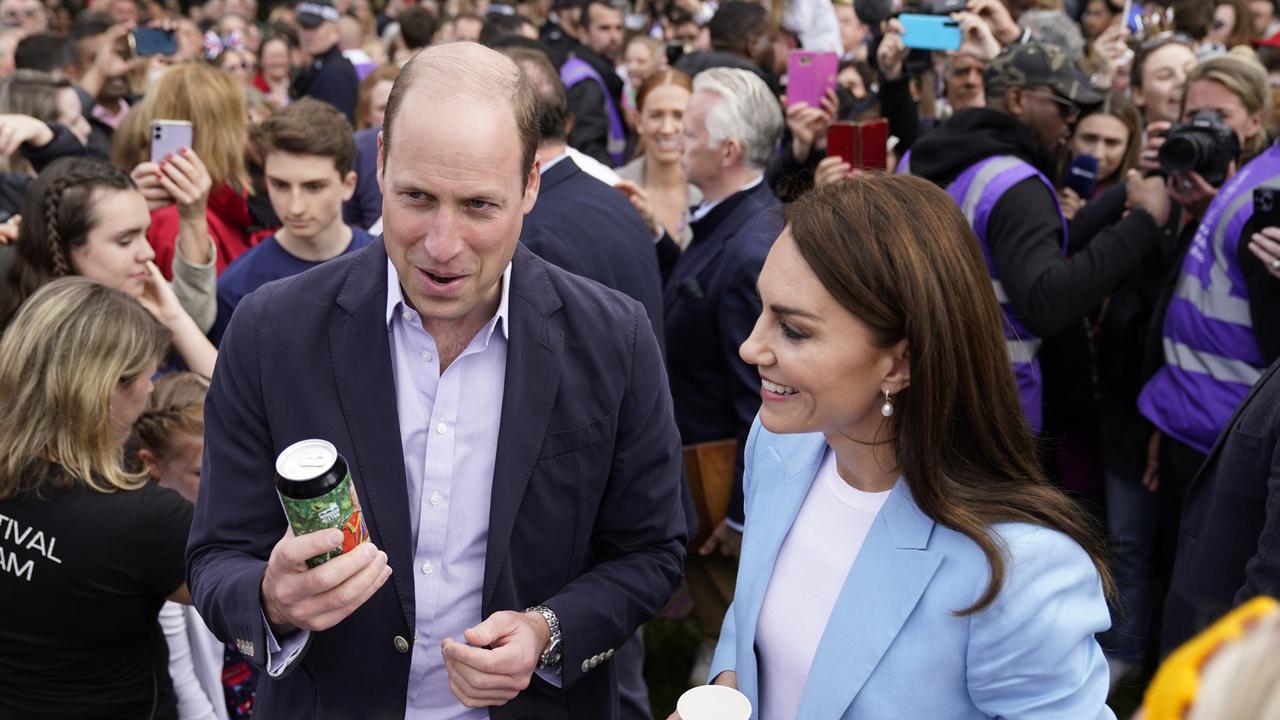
289,0,360,123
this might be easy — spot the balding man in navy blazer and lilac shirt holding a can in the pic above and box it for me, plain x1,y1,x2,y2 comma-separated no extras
188,44,686,720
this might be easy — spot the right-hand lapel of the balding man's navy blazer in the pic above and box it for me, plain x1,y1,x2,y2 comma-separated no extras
481,244,564,604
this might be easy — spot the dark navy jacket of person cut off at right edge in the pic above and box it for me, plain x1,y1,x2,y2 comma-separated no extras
1161,361,1280,653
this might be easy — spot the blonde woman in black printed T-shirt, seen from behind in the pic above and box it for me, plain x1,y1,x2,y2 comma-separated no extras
0,277,192,719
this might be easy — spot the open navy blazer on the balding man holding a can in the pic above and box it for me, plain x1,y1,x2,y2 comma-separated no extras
187,241,687,720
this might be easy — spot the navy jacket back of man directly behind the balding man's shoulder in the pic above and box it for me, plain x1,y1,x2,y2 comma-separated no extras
520,158,663,342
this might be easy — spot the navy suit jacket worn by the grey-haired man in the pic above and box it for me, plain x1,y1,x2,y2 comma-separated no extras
663,176,782,521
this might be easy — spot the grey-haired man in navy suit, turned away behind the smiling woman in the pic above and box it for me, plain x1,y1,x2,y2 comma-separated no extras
659,68,783,680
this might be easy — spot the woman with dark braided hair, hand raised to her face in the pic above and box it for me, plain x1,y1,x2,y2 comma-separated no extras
0,158,218,377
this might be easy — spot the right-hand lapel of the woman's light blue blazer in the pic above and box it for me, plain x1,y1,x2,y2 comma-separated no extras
797,479,942,720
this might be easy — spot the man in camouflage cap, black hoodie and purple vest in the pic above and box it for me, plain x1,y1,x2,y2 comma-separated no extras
904,42,1169,432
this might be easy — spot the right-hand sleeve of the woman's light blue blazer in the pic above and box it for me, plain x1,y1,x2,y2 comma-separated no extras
965,525,1115,720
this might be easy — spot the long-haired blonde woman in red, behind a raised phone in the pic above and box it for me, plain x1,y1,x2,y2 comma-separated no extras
111,63,252,277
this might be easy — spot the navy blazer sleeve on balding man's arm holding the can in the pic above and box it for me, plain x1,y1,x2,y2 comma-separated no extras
187,292,306,674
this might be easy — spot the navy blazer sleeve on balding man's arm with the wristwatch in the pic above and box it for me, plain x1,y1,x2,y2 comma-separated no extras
547,302,689,688
